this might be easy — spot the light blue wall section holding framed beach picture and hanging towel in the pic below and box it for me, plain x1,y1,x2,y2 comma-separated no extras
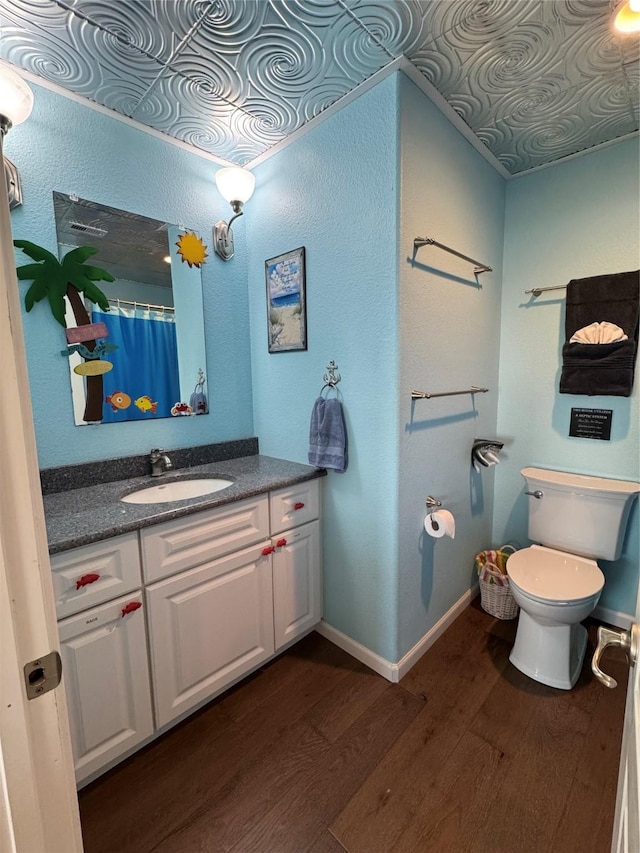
246,75,398,660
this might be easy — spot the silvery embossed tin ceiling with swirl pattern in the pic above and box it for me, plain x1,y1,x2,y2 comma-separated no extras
0,0,640,174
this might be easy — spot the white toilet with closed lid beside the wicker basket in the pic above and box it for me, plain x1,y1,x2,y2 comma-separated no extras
507,468,640,690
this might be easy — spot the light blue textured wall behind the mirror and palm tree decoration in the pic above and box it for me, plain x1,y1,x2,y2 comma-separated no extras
5,85,254,468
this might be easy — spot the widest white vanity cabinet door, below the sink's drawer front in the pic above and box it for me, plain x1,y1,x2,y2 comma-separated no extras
147,542,274,726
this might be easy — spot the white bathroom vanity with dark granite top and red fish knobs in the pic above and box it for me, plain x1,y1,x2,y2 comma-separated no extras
44,455,325,785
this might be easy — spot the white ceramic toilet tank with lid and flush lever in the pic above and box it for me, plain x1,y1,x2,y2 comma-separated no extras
521,468,640,560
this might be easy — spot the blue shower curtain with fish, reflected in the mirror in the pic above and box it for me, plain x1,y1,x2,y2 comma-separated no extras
92,305,180,423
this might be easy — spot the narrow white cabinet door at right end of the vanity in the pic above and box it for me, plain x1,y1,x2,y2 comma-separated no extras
272,521,322,649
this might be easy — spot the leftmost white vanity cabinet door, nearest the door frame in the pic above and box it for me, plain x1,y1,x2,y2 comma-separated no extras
58,590,153,782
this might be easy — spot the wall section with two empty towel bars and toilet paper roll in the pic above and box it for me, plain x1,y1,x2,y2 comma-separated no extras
398,75,505,657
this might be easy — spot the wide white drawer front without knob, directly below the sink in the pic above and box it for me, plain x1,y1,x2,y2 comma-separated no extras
140,495,269,583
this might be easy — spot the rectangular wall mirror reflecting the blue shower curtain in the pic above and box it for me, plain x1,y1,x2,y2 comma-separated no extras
53,192,208,426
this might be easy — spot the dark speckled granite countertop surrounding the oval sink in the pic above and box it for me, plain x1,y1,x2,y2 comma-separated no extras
43,455,326,554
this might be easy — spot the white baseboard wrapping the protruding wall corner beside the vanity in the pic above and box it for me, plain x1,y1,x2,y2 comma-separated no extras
315,585,479,684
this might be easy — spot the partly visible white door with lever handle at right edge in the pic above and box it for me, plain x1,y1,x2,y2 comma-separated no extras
591,587,640,853
